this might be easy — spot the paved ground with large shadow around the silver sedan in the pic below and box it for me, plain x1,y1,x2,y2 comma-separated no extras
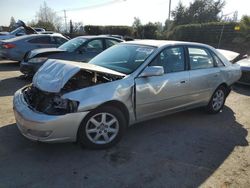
0,61,250,188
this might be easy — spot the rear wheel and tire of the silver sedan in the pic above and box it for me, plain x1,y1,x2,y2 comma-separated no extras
207,86,227,114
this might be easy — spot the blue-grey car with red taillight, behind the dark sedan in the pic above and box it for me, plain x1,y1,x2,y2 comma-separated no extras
0,34,68,61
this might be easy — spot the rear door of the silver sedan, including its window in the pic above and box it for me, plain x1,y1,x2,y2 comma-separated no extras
187,46,221,104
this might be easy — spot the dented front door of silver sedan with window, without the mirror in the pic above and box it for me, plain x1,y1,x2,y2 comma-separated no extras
135,46,189,119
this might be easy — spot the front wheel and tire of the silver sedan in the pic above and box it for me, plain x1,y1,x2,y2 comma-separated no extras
78,106,126,149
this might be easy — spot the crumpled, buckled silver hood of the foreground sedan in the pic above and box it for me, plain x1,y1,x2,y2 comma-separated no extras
32,59,125,93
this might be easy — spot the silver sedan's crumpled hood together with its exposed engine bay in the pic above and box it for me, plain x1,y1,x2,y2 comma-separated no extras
22,60,123,115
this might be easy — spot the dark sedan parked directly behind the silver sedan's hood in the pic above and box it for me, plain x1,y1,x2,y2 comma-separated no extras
20,36,123,76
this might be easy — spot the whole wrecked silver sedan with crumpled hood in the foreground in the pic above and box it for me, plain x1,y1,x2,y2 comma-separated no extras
13,40,241,148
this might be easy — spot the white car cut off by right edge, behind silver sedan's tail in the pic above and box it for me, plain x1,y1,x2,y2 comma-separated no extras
237,57,250,85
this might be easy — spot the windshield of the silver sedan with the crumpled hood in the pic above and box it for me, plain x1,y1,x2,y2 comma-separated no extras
89,44,155,74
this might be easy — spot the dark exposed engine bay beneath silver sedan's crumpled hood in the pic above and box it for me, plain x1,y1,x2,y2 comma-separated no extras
22,70,122,115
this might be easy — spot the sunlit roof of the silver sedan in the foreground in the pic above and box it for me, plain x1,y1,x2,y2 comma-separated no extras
125,39,209,48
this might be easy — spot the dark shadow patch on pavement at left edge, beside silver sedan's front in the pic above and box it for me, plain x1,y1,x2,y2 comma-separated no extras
0,77,31,97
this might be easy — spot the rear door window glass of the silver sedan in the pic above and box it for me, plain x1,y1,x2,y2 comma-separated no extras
188,47,214,70
